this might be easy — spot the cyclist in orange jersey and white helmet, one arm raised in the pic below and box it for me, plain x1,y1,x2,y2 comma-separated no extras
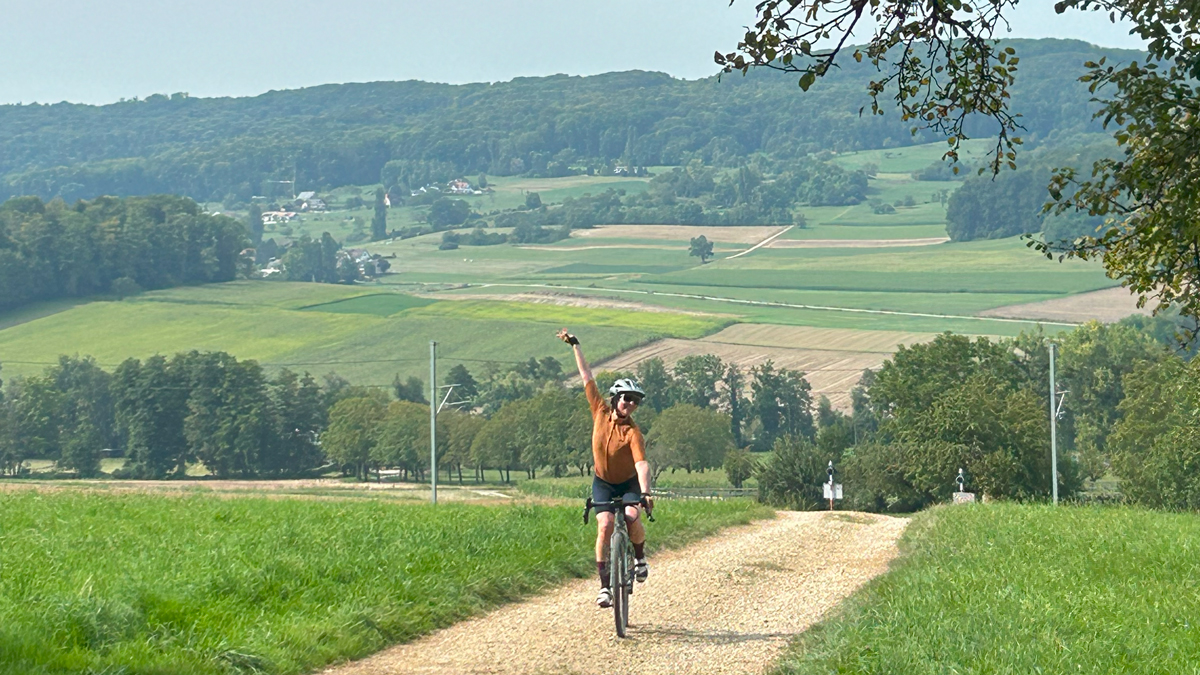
558,328,654,608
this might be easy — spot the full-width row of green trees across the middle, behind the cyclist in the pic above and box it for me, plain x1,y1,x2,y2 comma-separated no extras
0,317,1200,512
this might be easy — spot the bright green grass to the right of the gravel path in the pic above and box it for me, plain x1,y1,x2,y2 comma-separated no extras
776,504,1200,675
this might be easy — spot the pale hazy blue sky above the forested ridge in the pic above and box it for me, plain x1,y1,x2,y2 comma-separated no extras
0,0,1140,103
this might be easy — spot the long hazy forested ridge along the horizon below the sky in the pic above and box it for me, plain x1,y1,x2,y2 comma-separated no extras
0,40,1139,202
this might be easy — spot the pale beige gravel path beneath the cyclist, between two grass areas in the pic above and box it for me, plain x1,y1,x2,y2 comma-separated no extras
326,504,907,675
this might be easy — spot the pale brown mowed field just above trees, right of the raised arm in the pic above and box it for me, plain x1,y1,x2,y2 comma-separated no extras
596,323,934,411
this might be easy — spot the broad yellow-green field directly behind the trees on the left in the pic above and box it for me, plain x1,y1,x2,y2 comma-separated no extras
0,281,728,386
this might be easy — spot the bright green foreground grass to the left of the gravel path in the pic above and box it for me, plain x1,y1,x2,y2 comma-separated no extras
0,490,770,675
